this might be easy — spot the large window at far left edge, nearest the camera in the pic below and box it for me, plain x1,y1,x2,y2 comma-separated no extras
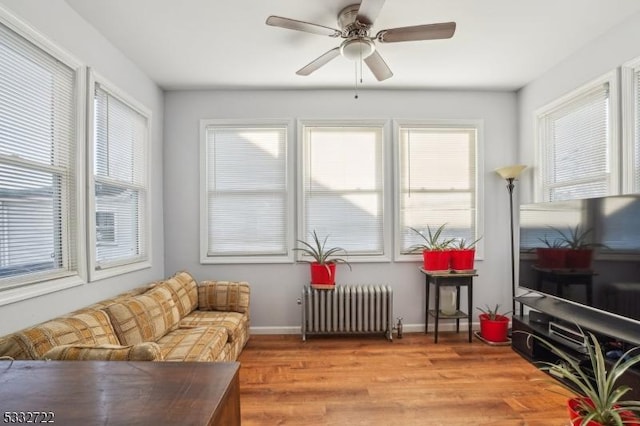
0,13,85,303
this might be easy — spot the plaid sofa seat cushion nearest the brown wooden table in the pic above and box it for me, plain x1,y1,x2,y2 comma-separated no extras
157,327,227,362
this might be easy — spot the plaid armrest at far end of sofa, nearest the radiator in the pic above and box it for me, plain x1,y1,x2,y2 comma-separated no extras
198,281,251,315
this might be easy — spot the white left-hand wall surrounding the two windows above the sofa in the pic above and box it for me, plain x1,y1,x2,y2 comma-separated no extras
0,0,164,335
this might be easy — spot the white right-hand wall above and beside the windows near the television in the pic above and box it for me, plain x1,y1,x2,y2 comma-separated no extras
518,13,640,203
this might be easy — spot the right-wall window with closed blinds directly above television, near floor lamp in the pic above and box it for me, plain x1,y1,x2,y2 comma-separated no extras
536,73,619,201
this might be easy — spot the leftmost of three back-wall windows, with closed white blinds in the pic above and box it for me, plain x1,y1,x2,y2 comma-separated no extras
200,120,293,263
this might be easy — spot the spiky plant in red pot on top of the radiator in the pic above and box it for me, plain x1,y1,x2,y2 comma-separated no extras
294,230,351,288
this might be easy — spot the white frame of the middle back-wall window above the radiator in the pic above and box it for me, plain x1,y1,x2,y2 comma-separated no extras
296,119,392,263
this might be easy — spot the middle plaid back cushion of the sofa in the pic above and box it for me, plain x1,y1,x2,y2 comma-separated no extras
105,286,180,345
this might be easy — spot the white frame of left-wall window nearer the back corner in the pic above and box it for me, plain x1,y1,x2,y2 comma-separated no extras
86,69,152,282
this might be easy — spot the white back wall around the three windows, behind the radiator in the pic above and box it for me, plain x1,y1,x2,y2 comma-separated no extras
164,90,517,332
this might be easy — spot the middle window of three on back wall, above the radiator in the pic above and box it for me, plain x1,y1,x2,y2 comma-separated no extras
298,121,388,261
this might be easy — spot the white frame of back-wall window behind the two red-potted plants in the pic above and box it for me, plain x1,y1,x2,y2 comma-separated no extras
393,119,484,262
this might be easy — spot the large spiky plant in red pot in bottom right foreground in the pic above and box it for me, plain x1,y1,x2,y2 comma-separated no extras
529,330,640,426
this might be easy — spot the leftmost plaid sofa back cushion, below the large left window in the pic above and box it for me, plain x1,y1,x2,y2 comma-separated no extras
0,311,120,359
